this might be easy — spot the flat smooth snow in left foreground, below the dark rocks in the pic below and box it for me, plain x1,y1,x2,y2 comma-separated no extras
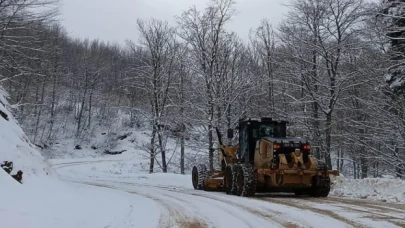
0,172,160,228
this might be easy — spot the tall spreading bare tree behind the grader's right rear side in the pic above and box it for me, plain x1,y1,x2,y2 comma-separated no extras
281,0,364,168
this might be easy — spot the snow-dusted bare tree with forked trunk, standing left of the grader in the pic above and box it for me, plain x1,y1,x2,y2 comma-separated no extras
137,20,178,173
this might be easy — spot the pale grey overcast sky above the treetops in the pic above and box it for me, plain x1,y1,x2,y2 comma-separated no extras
61,0,288,44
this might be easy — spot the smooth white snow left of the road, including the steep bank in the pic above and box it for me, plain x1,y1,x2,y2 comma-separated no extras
0,87,160,228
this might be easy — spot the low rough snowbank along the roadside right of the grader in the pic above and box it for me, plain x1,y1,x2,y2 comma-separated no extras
331,177,405,203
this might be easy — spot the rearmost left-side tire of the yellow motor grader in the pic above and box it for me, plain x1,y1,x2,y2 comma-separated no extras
235,164,257,197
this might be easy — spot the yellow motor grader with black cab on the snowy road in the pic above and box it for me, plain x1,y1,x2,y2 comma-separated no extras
192,118,339,197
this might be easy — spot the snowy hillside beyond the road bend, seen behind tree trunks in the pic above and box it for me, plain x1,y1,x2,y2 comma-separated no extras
38,120,208,173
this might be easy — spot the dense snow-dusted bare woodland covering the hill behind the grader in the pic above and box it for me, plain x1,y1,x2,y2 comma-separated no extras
0,0,405,178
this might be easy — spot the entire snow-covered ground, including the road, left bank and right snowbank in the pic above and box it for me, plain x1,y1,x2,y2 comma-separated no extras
0,85,405,228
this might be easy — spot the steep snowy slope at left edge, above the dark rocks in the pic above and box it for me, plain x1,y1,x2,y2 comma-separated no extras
0,87,51,180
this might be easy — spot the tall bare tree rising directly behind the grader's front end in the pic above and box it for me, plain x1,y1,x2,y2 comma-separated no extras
178,0,235,170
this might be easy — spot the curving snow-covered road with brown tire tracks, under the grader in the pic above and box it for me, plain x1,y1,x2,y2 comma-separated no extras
52,159,405,228
